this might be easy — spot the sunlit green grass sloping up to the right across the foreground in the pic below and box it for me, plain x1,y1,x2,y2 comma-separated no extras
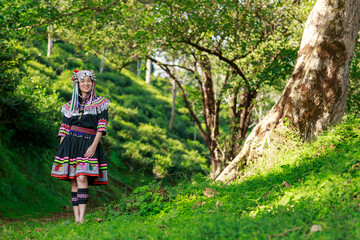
1,119,360,239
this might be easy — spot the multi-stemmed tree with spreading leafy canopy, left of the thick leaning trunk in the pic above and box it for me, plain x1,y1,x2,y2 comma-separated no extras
19,0,310,177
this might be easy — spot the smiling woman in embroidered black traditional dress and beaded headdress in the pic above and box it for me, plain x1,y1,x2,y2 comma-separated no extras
51,70,110,223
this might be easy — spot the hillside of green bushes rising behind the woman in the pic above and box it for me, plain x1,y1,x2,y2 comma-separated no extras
0,42,208,218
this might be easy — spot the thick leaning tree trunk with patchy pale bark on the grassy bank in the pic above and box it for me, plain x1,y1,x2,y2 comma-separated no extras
217,0,360,181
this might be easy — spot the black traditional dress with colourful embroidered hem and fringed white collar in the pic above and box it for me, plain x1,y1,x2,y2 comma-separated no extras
51,70,110,185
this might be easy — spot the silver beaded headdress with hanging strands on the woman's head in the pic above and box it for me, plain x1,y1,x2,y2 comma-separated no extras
70,70,96,113
